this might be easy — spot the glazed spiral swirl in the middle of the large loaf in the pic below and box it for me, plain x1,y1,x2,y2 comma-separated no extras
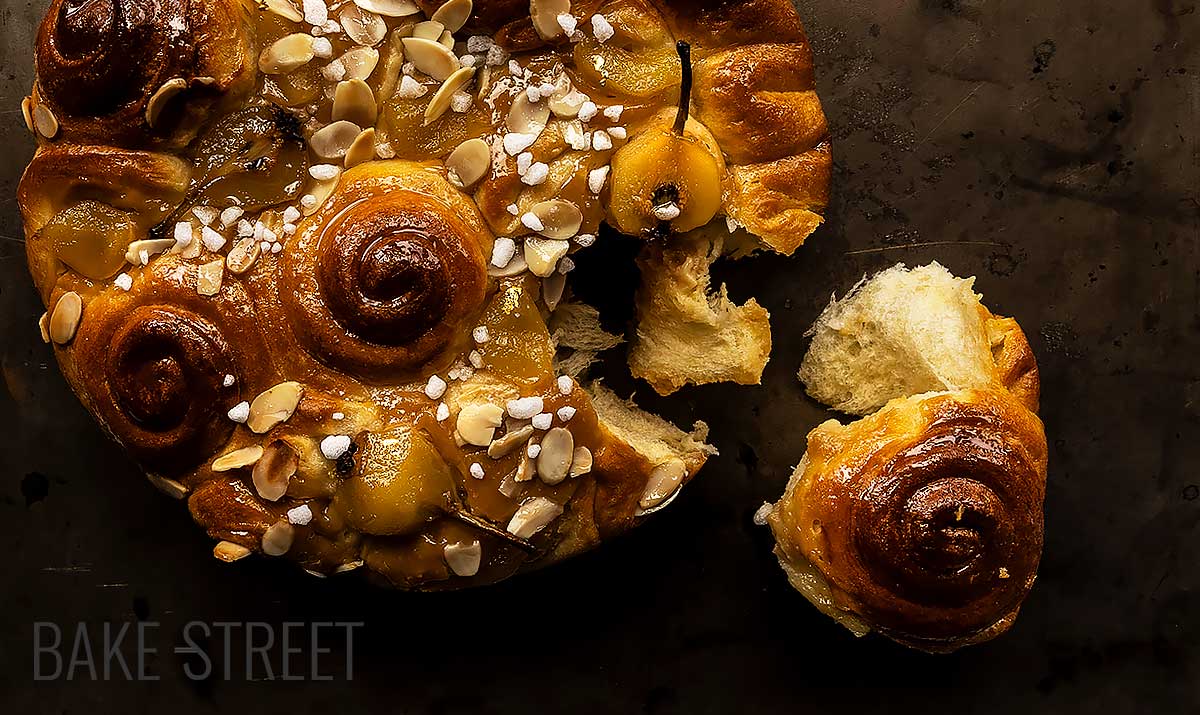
283,162,492,380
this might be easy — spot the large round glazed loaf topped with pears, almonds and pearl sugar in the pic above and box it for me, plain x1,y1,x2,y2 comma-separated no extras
19,0,829,589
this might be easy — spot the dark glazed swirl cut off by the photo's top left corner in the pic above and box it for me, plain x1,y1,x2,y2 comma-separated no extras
37,0,253,144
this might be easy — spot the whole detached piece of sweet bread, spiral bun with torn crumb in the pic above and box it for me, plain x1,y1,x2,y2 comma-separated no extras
760,264,1046,651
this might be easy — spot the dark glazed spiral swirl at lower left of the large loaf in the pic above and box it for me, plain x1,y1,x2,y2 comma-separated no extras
65,262,272,475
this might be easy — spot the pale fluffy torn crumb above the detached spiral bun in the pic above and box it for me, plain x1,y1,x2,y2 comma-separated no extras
799,263,997,415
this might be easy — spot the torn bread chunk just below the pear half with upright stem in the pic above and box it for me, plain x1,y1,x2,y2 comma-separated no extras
629,227,772,395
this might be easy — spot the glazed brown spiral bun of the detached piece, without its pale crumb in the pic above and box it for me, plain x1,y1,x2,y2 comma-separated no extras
772,391,1046,650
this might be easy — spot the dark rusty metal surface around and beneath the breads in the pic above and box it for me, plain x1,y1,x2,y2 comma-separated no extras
0,0,1200,714
